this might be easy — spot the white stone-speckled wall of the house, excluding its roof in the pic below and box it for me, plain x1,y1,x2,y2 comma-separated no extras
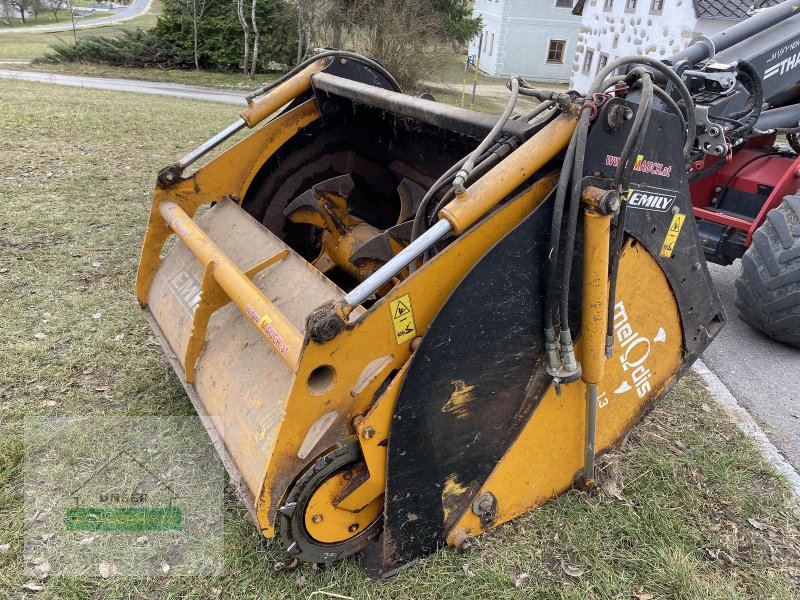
571,0,700,92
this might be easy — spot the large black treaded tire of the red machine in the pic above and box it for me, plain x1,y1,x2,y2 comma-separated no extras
736,196,800,348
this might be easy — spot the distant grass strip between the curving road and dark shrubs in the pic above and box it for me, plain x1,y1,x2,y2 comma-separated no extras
0,0,161,61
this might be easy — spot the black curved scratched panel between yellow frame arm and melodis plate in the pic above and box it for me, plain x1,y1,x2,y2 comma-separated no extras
376,197,553,562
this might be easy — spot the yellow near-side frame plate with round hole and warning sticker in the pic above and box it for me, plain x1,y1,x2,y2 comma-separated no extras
256,173,558,537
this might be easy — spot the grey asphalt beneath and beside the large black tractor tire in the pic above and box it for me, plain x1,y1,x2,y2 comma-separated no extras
702,260,800,471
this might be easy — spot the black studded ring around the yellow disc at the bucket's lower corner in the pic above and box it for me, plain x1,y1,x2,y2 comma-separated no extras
278,440,382,564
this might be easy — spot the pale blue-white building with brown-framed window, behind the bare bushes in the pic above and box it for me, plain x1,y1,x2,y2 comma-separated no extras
469,0,581,83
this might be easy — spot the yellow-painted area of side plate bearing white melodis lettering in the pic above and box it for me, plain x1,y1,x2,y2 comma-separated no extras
447,242,683,544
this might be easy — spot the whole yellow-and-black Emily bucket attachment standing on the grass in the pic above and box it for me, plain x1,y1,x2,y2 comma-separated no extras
137,51,721,577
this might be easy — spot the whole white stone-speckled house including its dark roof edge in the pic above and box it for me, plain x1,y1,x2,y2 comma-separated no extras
571,0,781,91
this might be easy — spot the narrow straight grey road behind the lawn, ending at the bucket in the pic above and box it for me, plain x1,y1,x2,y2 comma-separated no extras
0,69,247,106
